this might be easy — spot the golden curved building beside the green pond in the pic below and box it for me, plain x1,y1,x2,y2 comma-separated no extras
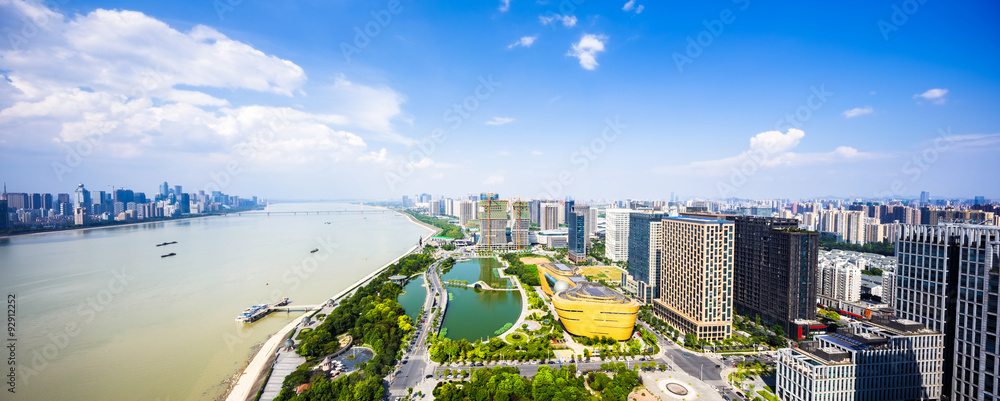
538,263,639,341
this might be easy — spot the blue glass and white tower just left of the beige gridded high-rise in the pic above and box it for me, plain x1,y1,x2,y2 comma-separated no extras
624,211,667,304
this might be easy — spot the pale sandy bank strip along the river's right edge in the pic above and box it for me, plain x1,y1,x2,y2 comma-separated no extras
224,206,441,401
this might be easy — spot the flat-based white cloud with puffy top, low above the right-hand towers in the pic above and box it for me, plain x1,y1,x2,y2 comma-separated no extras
654,128,881,177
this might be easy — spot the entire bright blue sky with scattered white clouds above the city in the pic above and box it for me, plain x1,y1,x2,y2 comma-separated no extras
0,0,1000,199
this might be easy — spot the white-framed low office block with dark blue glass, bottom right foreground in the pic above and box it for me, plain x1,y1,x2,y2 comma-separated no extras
775,315,945,401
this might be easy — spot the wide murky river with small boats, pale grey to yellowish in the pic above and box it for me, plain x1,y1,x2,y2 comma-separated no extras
0,203,430,401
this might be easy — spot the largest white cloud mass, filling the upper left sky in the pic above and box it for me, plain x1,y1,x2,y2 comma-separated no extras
0,0,407,164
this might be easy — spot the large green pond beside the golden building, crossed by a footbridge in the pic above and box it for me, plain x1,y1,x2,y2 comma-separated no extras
442,258,521,342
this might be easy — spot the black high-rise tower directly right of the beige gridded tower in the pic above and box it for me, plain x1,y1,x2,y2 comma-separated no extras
733,216,826,340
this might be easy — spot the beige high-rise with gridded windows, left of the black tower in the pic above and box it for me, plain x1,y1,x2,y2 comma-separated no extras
653,217,733,340
